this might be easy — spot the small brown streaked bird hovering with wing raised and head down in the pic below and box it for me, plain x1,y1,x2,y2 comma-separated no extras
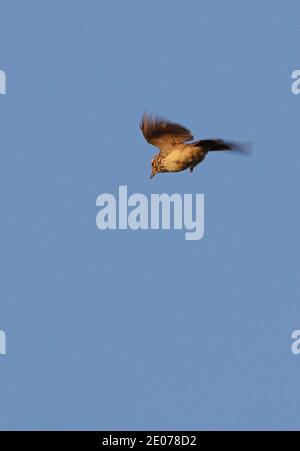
140,113,245,179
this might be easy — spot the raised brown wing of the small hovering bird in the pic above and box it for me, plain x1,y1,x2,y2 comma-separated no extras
140,114,193,153
